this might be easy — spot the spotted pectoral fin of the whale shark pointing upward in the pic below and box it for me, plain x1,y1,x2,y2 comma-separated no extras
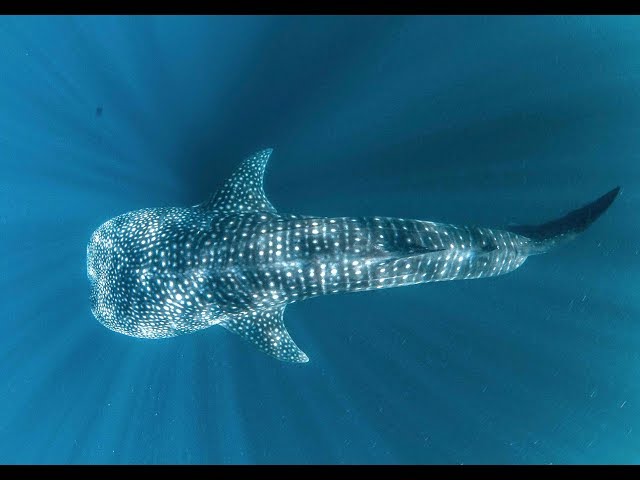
197,148,277,215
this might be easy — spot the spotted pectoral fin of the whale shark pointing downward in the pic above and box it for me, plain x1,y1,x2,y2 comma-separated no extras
220,306,309,363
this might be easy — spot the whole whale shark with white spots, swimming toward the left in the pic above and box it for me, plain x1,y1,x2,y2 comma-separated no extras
87,149,620,363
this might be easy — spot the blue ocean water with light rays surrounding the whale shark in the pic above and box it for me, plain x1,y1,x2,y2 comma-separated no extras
0,16,640,464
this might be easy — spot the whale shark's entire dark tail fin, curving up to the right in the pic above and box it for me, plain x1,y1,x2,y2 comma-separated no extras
507,187,620,255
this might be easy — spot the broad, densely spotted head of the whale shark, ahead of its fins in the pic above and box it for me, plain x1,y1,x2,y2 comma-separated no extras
87,208,217,338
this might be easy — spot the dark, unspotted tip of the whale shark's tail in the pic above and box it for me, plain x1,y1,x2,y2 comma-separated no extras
509,187,620,241
